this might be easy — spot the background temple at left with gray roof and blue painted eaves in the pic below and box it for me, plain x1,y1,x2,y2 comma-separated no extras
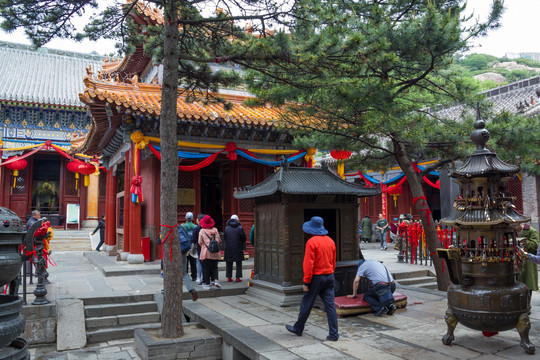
0,41,105,226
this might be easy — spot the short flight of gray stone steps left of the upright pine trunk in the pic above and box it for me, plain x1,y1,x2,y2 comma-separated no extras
83,294,161,343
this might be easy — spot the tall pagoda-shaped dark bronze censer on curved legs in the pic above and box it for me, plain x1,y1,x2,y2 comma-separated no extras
437,111,535,354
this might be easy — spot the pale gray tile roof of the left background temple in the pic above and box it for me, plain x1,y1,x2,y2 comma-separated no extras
0,41,103,107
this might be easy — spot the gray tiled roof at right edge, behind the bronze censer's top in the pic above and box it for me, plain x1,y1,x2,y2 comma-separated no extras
433,76,540,119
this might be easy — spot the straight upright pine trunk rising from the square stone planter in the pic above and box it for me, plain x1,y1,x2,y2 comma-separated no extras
159,0,184,338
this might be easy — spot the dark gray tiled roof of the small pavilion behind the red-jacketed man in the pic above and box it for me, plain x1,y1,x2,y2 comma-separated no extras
234,167,381,199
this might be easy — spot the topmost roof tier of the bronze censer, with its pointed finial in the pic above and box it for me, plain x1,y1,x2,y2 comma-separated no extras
452,111,519,180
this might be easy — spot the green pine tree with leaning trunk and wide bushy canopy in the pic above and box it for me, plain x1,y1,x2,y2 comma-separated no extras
245,0,503,290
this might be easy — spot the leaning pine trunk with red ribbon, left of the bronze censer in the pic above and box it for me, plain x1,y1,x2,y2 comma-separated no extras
392,139,450,291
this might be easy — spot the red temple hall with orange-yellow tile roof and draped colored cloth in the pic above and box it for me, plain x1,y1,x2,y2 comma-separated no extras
72,3,306,263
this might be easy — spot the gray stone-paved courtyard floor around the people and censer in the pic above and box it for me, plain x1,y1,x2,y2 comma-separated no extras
24,249,540,360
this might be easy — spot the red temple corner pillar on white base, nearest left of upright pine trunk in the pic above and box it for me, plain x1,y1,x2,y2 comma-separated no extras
125,146,144,264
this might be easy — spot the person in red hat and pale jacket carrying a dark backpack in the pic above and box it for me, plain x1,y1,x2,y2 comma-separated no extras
198,215,221,290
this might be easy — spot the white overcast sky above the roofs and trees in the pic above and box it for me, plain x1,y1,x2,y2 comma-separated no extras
0,0,540,57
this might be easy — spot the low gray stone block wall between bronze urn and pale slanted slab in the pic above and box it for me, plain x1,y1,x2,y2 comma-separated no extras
21,304,56,344
